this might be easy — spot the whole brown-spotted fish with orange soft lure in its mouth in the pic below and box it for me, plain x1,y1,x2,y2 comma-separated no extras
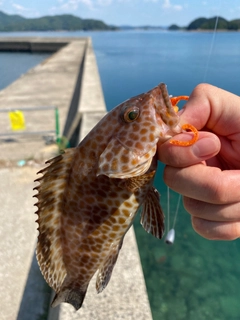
34,83,198,310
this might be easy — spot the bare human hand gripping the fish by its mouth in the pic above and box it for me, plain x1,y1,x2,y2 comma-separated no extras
158,84,240,240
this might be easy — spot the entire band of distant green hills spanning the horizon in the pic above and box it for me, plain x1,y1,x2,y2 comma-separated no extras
0,11,240,32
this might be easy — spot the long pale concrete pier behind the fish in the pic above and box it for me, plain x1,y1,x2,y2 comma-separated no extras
0,38,152,320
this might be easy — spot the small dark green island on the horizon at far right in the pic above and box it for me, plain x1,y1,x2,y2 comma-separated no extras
168,17,240,31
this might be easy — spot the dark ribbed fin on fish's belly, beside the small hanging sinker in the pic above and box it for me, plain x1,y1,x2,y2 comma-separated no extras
140,187,164,239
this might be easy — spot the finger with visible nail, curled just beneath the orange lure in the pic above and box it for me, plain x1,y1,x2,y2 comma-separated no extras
157,131,221,168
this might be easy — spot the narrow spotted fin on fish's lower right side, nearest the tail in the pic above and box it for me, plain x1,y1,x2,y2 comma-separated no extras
96,241,122,293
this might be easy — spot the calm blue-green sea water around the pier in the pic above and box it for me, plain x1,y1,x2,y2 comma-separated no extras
0,30,240,320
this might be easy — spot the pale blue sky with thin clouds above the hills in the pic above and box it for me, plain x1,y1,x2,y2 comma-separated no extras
0,0,240,26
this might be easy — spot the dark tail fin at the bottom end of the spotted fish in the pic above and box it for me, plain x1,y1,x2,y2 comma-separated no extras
51,285,87,310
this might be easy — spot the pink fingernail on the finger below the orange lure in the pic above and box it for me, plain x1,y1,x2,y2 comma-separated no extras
192,138,219,158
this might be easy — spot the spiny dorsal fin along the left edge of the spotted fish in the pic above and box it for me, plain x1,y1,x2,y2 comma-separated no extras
34,149,74,292
